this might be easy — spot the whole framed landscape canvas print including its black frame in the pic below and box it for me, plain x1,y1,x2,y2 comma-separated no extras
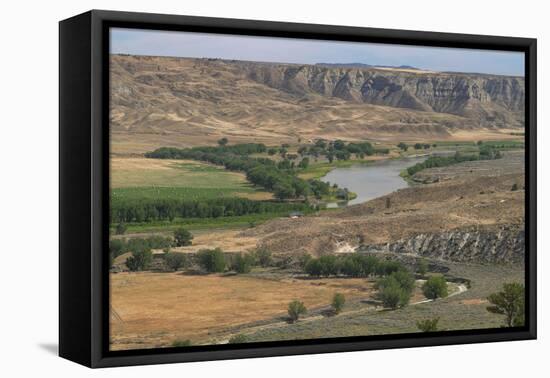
59,11,536,367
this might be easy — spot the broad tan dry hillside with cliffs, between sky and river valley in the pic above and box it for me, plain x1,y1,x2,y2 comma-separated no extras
111,55,523,154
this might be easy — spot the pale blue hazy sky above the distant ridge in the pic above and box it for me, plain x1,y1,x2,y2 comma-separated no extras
111,28,525,76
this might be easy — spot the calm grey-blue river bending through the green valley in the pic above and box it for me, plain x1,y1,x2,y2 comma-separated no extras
321,156,426,208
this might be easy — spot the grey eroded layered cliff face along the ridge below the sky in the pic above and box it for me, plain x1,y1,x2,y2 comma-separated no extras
245,63,525,126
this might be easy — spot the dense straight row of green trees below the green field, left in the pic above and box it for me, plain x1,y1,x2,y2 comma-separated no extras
110,197,312,223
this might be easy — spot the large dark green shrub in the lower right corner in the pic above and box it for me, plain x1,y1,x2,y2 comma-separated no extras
487,283,525,327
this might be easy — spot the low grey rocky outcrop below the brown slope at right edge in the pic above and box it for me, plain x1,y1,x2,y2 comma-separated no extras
358,227,525,263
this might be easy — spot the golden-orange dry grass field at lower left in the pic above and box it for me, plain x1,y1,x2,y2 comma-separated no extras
111,272,380,350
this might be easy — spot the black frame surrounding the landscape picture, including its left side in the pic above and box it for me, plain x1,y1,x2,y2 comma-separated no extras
59,10,537,368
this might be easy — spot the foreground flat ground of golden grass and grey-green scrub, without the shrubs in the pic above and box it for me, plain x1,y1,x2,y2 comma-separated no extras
111,261,524,350
